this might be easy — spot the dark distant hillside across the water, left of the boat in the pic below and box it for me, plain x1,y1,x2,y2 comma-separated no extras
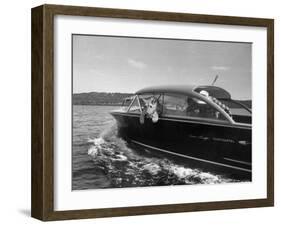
72,92,133,106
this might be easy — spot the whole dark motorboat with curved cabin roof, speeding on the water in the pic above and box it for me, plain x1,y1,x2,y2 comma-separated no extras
110,85,252,180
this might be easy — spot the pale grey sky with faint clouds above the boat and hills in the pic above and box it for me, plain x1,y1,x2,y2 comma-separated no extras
72,35,252,99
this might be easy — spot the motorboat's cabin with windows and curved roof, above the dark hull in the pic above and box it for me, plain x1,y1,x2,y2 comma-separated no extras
120,86,252,124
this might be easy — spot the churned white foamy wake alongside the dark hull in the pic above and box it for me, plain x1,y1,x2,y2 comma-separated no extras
88,122,234,188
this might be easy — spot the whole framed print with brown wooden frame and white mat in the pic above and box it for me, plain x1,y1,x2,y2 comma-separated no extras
32,5,274,221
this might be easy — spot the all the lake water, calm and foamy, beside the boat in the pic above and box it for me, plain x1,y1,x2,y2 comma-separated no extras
72,105,235,190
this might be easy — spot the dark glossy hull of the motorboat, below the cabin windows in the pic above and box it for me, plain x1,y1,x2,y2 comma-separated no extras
111,112,252,180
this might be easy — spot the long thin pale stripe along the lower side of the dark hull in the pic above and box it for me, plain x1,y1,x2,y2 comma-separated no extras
131,140,252,173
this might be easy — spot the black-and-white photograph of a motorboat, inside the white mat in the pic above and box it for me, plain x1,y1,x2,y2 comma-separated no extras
72,34,252,190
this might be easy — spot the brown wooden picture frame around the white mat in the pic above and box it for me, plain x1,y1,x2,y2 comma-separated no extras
31,5,274,221
